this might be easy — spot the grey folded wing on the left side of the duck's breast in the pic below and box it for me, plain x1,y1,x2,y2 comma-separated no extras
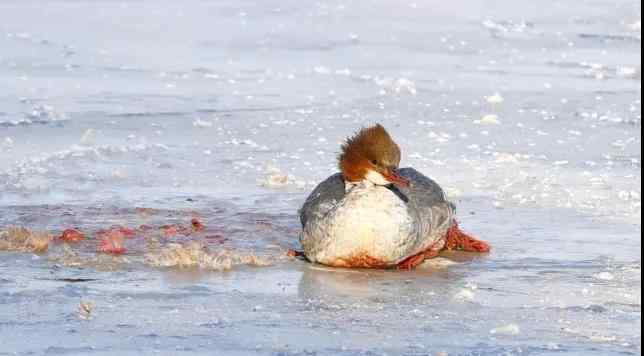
300,173,347,227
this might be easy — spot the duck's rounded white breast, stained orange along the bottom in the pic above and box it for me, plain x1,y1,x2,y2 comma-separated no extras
301,184,429,267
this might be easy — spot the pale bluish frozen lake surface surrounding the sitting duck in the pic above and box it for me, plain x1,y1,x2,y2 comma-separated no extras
0,0,642,356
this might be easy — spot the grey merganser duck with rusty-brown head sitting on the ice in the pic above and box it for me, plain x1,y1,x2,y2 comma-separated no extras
300,125,490,269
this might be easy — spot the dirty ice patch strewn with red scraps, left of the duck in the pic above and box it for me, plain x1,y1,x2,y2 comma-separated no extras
0,206,297,271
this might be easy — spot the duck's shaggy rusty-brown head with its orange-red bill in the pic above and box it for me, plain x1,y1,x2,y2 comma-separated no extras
339,125,409,187
